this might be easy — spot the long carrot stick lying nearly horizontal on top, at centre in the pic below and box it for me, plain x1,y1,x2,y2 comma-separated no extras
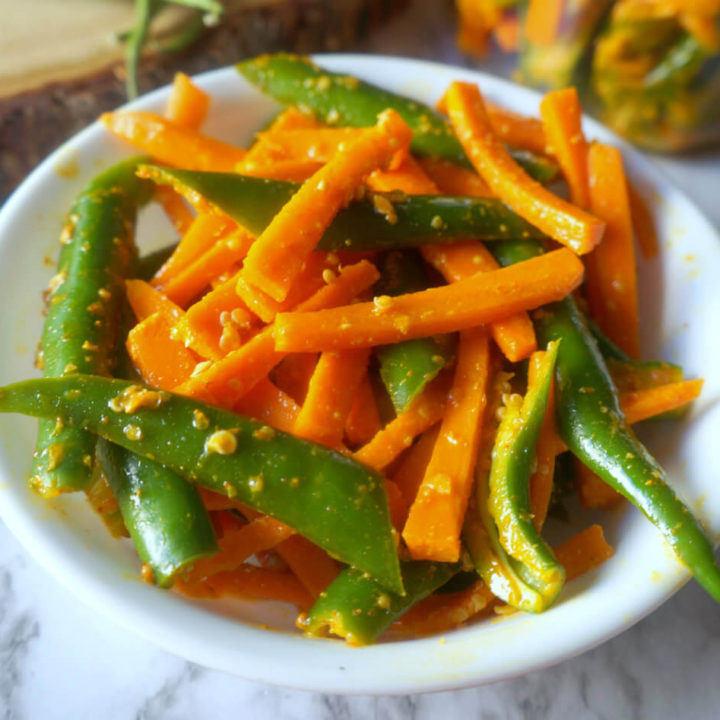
274,248,583,352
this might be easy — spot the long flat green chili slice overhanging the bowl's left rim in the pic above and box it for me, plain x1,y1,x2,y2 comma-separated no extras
0,375,403,593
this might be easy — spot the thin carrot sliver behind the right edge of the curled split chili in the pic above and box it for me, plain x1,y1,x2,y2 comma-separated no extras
528,351,558,529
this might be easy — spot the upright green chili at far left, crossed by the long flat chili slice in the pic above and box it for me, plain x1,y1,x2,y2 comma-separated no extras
31,158,152,496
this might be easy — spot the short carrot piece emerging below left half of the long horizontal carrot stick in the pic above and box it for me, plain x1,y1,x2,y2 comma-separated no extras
293,348,370,447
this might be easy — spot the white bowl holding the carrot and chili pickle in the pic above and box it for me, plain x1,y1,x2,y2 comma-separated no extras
0,55,720,694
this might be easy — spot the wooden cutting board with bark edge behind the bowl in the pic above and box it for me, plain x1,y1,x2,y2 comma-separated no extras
0,0,408,202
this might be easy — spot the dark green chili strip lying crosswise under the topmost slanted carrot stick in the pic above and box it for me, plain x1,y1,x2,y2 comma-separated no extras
143,166,543,251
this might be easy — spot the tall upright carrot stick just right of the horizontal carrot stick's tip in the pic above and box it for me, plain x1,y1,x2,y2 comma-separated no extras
586,143,639,357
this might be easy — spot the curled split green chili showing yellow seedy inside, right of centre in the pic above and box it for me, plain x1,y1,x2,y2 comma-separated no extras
488,342,565,605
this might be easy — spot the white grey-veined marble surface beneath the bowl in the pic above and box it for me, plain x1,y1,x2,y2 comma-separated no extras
0,0,720,720
